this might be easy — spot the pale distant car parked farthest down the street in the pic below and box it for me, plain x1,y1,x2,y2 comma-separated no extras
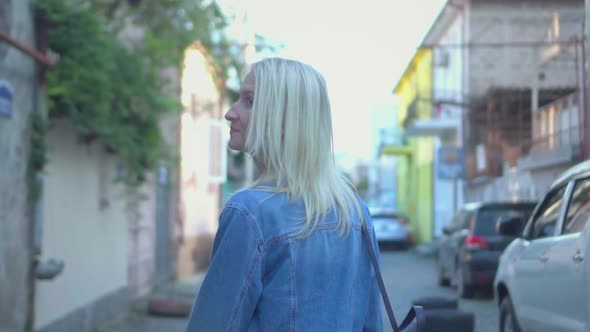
369,207,412,249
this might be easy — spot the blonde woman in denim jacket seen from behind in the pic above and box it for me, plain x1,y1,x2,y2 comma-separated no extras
187,58,382,332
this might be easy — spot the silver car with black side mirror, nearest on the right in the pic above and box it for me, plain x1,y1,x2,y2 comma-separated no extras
494,161,590,332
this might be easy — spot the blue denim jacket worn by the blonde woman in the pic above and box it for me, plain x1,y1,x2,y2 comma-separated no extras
187,188,383,332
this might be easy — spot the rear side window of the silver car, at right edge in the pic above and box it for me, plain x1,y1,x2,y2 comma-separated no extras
563,178,590,234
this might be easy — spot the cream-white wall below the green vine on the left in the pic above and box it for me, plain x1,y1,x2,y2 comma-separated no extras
35,122,128,331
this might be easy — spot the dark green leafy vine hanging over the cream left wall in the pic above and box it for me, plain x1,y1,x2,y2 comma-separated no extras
36,0,179,186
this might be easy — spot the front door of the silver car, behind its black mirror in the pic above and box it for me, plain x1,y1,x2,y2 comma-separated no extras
511,185,566,332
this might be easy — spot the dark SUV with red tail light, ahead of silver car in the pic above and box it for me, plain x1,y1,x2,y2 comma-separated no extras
436,202,535,298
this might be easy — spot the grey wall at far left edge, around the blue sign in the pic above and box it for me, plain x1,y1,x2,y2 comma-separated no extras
0,0,37,332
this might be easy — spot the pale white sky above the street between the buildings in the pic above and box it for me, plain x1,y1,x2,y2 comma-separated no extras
224,0,445,167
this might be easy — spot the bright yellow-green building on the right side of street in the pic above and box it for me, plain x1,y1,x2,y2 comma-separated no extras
382,49,434,243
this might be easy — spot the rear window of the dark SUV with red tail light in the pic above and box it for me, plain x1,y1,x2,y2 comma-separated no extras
474,204,535,235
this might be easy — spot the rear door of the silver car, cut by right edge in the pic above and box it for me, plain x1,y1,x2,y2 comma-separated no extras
541,178,590,332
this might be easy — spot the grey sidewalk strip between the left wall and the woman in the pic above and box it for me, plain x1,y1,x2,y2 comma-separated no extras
97,272,205,332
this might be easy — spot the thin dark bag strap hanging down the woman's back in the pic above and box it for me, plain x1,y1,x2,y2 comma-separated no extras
361,218,424,332
